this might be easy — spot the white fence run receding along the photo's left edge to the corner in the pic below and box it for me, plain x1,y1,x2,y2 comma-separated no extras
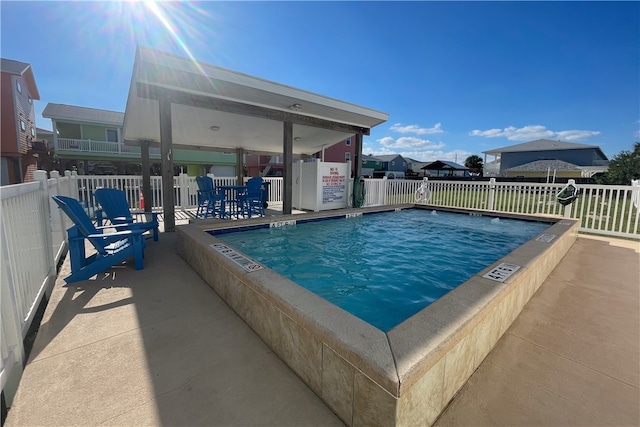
0,171,77,404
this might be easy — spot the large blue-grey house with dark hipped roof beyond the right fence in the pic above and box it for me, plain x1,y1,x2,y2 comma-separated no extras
483,139,609,178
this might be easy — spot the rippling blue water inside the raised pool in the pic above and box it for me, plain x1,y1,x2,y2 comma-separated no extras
216,209,549,332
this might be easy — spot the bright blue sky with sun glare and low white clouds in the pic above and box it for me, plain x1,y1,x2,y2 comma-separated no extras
0,0,640,163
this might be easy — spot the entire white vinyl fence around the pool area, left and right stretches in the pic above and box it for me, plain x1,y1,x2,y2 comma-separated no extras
0,171,640,405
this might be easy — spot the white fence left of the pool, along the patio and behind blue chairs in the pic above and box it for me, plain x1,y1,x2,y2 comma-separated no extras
0,171,282,405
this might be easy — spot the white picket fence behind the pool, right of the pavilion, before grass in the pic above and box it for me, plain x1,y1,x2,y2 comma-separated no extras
365,179,640,239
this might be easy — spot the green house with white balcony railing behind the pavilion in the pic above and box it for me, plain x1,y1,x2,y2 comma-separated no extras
42,103,236,176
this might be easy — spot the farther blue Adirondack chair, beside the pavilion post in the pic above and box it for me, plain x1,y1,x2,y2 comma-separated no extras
94,188,159,242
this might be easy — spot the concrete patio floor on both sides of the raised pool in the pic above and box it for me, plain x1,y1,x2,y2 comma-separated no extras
6,213,640,426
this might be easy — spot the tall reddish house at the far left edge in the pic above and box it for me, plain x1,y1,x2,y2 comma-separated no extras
0,58,40,185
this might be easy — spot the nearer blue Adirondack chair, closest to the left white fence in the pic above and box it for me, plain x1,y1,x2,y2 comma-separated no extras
52,196,146,283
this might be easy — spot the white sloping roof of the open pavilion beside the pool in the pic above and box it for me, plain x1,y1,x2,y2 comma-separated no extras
123,47,389,154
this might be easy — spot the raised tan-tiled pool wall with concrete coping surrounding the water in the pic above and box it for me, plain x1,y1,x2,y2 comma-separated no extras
176,204,580,426
